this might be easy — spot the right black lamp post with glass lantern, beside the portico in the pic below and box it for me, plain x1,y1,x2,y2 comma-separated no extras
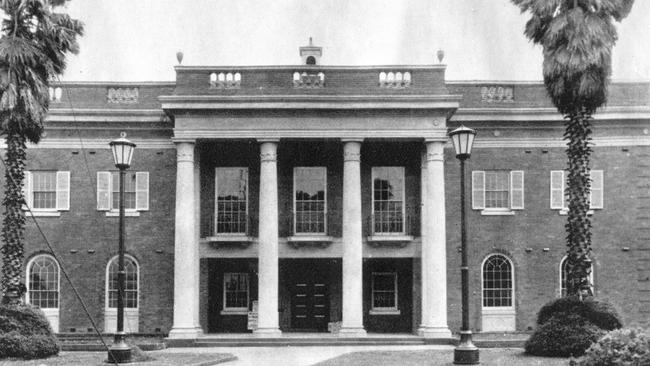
449,126,479,365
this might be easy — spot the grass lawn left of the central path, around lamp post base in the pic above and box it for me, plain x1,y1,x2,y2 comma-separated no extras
0,351,236,366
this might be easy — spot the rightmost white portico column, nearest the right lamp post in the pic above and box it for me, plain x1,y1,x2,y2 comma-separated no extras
418,141,451,338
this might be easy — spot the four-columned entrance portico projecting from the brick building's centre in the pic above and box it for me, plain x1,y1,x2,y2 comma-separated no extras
160,61,459,338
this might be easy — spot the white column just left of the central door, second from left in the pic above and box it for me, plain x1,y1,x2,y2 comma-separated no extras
255,140,281,337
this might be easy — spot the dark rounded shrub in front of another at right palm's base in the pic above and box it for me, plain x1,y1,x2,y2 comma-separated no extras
524,314,605,357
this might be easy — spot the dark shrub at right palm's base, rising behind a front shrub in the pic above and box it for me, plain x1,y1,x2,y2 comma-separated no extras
537,296,623,330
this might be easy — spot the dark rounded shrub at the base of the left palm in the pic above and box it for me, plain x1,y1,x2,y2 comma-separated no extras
0,305,59,359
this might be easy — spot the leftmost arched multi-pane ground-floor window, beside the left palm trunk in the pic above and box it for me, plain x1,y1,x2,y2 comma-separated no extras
27,255,59,309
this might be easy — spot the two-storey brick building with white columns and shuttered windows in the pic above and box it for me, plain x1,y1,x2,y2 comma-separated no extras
13,46,650,338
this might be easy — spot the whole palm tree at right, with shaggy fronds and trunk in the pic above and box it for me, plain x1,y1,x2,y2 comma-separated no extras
512,0,634,297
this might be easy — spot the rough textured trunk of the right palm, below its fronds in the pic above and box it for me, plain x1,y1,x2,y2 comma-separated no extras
564,109,592,298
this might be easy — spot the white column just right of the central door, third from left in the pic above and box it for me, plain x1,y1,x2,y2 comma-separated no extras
339,140,366,337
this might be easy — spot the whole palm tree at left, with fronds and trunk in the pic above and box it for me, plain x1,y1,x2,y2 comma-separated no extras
0,0,83,303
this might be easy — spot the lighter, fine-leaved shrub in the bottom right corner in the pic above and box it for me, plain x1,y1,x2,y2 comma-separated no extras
578,329,650,366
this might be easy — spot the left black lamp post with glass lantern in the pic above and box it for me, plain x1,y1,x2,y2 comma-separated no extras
108,132,135,363
